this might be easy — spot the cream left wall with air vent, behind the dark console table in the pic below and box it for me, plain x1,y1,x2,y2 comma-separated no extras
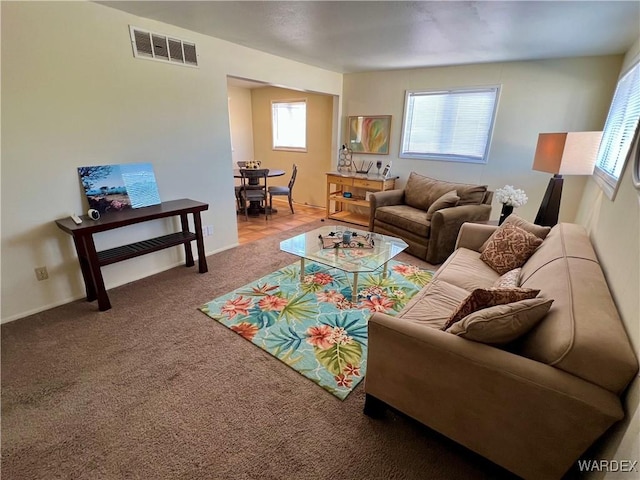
0,2,342,322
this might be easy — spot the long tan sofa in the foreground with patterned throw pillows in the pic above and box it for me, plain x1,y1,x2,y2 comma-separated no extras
365,216,638,480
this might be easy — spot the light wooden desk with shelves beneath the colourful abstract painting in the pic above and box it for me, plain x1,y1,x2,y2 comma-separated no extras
327,172,399,227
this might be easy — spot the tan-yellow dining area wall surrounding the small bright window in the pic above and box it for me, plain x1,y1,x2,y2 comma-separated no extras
251,87,337,206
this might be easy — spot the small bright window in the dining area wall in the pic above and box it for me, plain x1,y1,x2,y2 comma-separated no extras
271,100,307,152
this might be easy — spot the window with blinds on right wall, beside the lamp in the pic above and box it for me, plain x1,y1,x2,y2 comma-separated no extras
594,61,640,200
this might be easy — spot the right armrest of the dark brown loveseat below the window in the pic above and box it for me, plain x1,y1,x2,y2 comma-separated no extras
426,204,491,264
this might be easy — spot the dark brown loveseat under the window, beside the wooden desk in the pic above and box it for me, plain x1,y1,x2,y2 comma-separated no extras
369,172,493,264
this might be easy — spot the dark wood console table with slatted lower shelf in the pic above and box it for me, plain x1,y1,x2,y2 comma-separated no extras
56,199,209,311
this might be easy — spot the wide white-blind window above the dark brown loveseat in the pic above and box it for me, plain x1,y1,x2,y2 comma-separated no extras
400,87,500,163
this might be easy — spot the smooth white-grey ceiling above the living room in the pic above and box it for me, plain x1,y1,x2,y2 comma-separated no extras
97,1,640,73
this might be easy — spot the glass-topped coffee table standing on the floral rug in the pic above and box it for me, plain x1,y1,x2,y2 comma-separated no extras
280,225,408,302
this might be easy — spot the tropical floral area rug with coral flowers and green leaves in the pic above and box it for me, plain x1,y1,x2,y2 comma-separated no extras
199,260,433,400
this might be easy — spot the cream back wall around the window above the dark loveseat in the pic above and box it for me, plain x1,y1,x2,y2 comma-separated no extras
341,56,622,221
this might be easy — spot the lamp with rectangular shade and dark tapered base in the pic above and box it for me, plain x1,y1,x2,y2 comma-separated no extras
532,132,602,227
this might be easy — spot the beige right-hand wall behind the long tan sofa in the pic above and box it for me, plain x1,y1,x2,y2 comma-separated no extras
577,40,640,478
